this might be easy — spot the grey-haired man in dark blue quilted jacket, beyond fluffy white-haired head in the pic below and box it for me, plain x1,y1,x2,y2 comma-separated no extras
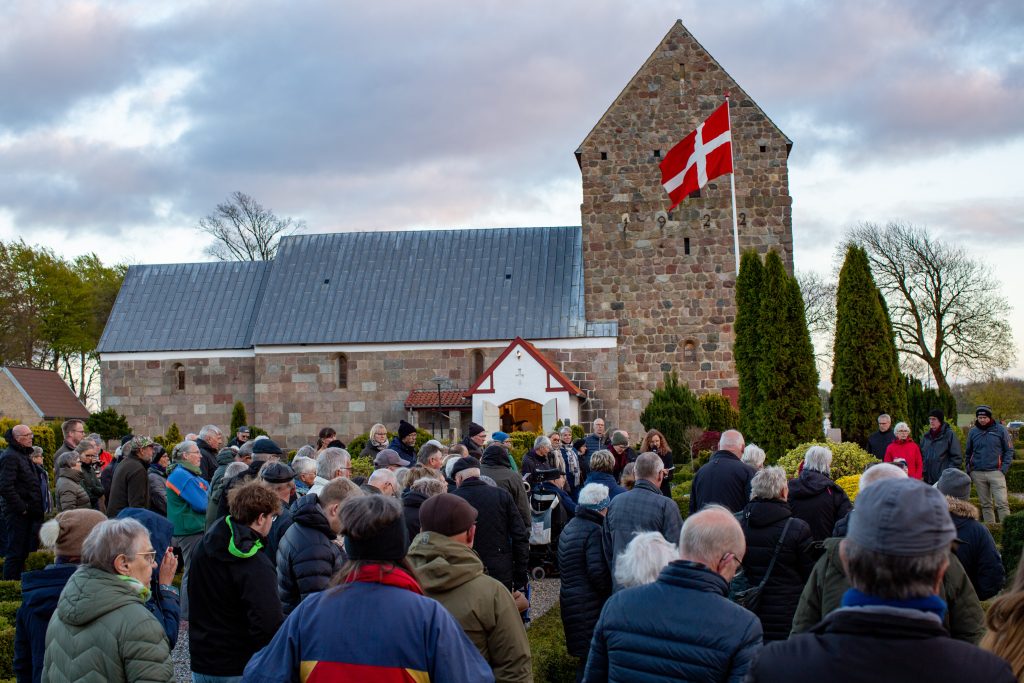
604,453,682,590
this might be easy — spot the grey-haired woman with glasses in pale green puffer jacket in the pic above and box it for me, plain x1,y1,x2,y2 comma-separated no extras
42,519,175,683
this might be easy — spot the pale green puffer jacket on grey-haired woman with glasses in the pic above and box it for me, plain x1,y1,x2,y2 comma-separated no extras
42,567,175,683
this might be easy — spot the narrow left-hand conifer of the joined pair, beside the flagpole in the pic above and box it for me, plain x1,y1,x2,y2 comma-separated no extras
732,249,764,442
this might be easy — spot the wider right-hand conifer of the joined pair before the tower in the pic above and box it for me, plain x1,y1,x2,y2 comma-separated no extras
749,251,821,460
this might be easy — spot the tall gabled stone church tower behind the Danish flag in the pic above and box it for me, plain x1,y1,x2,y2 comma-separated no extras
580,24,793,425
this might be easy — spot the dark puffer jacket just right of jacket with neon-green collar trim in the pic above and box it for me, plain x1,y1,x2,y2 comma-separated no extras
278,494,345,614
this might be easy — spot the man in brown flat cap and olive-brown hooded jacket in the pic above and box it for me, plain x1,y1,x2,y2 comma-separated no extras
407,494,532,682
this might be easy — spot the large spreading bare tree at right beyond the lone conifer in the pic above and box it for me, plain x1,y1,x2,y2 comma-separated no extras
849,223,1015,391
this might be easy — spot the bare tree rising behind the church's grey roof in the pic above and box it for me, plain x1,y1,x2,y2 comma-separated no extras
197,193,305,261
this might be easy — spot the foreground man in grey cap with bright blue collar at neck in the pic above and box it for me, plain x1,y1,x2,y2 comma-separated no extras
748,478,1017,683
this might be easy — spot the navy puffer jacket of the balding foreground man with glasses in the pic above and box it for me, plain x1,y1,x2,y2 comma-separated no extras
583,560,761,683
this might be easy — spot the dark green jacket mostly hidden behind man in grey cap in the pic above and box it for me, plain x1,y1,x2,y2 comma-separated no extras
793,539,985,644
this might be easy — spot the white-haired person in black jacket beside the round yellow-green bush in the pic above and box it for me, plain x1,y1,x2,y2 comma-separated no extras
790,445,853,541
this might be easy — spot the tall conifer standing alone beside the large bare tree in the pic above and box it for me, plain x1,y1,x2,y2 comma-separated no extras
831,245,906,445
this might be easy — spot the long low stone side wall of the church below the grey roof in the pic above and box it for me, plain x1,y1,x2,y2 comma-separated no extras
101,348,614,449
